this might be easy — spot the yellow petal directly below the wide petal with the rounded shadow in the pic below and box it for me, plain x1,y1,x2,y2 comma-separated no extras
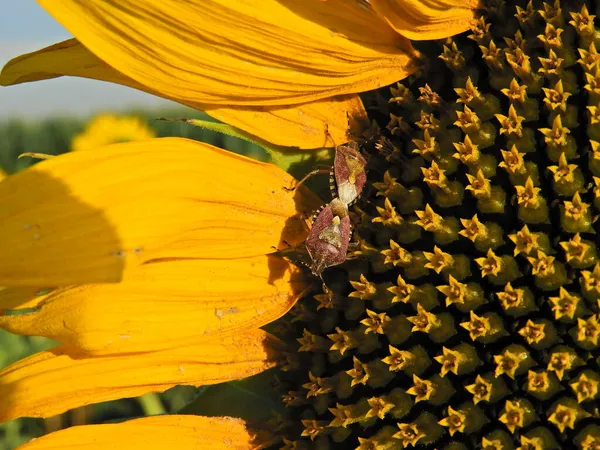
0,255,306,356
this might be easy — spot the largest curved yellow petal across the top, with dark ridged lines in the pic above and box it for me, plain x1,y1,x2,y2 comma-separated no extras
30,0,414,106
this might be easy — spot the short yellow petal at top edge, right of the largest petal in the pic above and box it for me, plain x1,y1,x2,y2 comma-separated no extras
370,0,481,41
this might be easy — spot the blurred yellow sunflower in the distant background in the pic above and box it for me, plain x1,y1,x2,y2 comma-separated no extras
71,114,156,151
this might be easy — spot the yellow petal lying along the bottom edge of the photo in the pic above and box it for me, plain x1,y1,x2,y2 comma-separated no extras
18,415,264,450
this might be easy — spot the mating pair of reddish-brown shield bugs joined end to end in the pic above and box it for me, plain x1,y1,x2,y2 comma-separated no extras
296,141,367,277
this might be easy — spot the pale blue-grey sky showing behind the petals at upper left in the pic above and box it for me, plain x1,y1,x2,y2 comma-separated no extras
0,0,170,120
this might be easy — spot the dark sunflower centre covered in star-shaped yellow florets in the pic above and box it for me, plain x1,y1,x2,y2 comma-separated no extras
278,1,600,450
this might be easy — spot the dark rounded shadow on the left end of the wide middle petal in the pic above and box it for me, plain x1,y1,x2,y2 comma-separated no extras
0,166,124,288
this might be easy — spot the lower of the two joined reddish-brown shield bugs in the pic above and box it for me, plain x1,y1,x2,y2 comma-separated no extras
305,198,352,278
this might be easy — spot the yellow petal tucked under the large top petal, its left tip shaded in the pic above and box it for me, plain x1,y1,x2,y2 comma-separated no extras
0,39,366,148
